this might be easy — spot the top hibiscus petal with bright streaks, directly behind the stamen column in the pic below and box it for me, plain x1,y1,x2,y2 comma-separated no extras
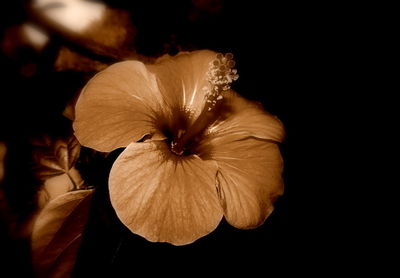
147,50,217,122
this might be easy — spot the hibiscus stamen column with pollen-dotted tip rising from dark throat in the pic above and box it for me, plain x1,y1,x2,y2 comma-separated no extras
171,53,239,155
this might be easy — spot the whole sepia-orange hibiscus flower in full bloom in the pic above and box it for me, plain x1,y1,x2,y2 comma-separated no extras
74,50,284,245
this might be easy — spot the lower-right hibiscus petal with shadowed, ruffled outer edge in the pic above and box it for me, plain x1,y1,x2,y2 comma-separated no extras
201,134,283,229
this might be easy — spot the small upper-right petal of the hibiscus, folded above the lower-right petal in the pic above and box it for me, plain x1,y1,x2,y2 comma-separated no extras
208,91,285,142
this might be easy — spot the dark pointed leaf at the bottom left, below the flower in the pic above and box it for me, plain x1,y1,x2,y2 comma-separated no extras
31,190,93,278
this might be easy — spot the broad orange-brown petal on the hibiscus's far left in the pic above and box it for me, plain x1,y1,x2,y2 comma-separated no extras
74,61,162,152
